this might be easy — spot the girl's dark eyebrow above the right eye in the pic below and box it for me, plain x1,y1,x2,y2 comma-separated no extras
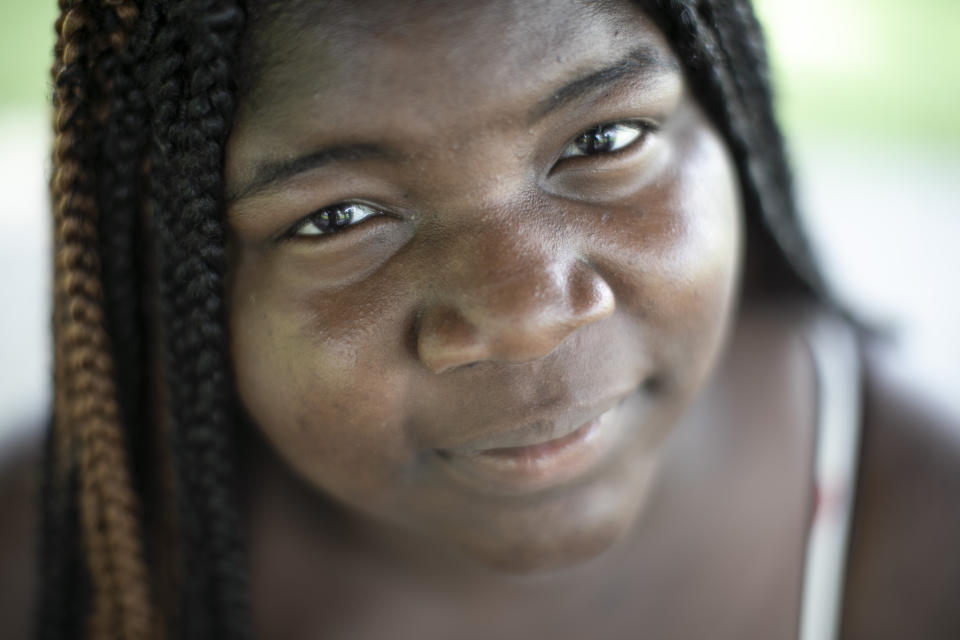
529,46,681,123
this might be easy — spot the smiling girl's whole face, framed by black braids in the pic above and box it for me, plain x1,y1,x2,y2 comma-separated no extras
227,0,741,571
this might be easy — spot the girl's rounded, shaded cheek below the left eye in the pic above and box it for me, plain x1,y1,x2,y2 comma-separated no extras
230,251,415,501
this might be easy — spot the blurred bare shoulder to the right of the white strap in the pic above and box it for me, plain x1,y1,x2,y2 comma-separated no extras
843,350,960,640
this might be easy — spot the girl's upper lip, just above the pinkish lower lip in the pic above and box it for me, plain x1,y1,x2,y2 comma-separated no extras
438,391,630,456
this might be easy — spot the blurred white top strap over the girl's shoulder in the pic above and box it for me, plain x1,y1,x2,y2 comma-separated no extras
798,316,861,640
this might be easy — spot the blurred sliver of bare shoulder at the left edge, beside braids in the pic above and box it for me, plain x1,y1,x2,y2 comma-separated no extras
0,429,41,640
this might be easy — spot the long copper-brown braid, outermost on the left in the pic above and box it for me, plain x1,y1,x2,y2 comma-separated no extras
51,2,152,638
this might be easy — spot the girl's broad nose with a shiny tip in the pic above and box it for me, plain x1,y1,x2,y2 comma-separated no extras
416,226,615,373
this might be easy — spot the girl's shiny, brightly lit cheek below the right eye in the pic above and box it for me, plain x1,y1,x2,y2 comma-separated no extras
592,115,743,384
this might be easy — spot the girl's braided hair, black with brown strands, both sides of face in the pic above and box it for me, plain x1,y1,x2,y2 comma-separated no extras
37,0,828,640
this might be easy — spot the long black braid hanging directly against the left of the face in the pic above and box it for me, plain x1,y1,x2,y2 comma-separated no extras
152,0,251,638
